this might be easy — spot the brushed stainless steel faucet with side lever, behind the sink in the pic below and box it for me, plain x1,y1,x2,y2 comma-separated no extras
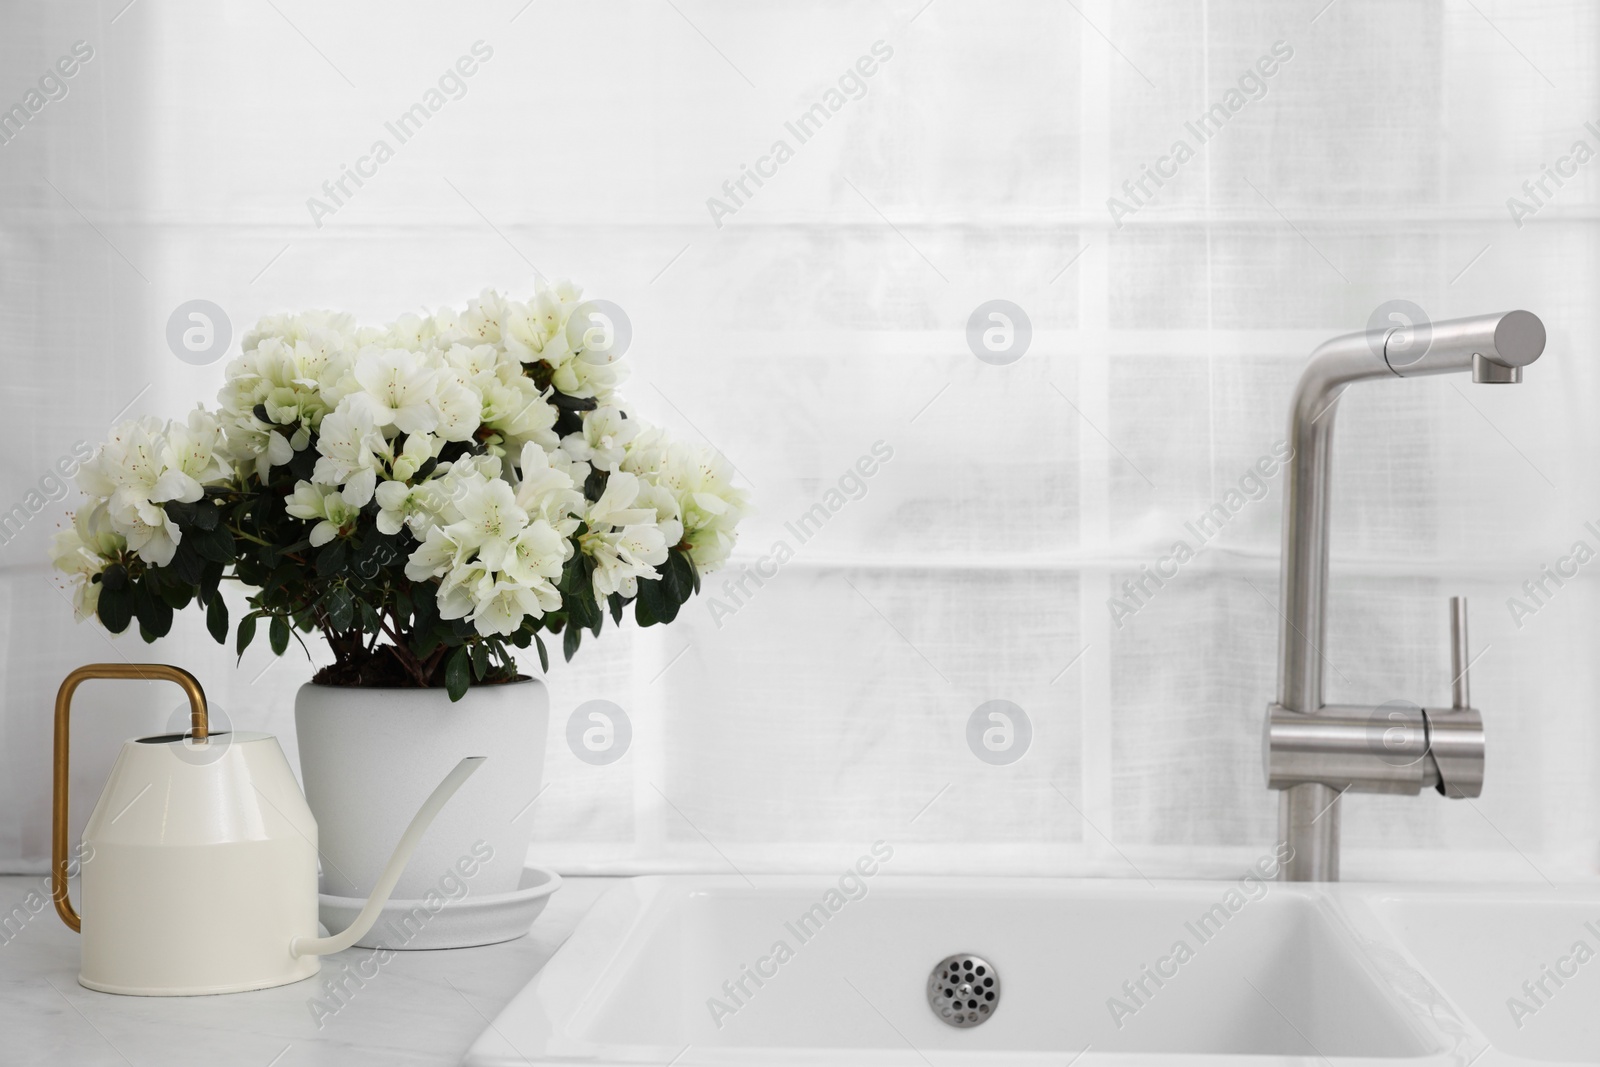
1262,310,1544,881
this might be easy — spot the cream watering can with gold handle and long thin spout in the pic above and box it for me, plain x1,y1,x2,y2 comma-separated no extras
51,664,483,997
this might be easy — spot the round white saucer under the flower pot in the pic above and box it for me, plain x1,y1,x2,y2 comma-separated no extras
317,867,562,949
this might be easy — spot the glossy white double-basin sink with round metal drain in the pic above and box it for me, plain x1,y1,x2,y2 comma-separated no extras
466,875,1600,1067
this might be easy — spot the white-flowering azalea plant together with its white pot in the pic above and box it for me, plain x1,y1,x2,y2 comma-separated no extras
53,285,746,940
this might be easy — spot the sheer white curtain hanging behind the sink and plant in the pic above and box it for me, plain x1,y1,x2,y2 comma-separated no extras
0,0,1600,881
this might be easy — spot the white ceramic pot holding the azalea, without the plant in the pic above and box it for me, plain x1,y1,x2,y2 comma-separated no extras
294,678,550,899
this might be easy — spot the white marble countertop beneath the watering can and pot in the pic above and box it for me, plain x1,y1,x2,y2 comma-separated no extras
0,877,611,1067
